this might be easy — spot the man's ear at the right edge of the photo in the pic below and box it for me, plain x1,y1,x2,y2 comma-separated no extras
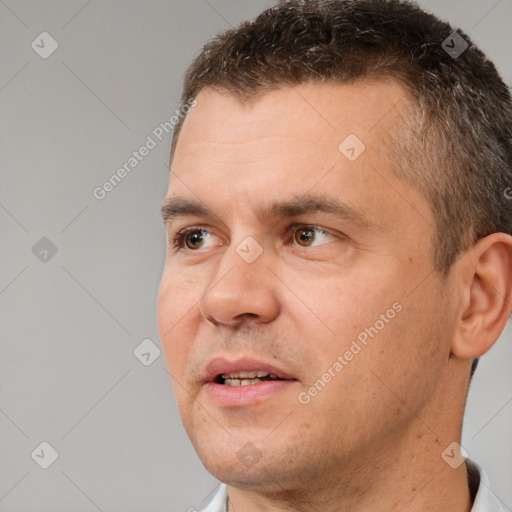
452,233,512,359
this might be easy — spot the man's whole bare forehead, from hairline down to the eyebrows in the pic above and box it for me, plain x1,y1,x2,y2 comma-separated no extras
168,81,430,238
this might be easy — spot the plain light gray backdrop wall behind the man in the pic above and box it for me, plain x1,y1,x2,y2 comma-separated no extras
0,0,512,512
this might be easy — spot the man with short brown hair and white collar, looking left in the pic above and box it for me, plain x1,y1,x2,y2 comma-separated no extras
158,0,512,512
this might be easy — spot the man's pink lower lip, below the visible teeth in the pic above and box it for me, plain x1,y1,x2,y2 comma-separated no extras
204,380,298,407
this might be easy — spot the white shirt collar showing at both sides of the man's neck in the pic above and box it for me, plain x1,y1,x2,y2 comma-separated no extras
200,459,510,512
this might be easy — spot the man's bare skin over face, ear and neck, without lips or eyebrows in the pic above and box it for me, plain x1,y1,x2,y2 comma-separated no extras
158,82,511,512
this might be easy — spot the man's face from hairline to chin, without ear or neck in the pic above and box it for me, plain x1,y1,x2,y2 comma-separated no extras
158,82,452,489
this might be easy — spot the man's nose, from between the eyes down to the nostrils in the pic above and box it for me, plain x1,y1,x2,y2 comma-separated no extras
199,240,280,327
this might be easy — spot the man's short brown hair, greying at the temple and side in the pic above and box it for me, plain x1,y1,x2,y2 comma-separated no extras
171,0,512,274
